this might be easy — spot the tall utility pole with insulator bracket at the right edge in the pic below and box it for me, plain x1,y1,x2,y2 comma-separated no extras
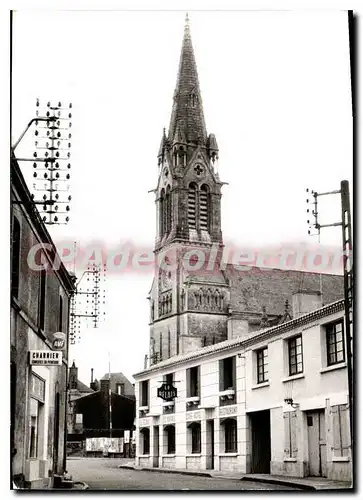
306,180,354,444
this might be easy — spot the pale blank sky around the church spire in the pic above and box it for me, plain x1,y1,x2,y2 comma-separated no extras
12,10,352,383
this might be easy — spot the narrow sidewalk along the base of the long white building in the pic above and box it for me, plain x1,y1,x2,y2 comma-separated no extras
119,460,352,491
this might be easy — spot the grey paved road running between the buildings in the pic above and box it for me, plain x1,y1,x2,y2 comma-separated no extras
67,458,296,491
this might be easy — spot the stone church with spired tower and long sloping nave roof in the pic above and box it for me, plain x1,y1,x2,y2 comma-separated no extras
148,15,343,365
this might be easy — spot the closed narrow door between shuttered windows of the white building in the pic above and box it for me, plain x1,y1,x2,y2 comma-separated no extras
306,410,326,477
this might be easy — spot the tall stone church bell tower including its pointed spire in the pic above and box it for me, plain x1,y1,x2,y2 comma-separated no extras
149,16,229,363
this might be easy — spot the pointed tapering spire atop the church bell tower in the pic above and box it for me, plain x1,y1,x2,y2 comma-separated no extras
168,14,207,145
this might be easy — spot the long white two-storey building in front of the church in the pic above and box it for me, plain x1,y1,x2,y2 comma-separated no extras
134,294,352,480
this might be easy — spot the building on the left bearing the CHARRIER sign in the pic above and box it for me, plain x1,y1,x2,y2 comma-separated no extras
10,158,74,488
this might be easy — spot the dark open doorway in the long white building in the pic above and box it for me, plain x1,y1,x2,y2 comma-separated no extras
249,410,271,474
